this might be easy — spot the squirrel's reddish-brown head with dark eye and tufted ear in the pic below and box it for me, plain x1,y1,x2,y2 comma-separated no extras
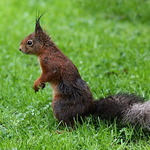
19,14,46,56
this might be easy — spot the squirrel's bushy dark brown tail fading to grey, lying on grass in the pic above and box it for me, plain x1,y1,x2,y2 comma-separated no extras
92,94,150,130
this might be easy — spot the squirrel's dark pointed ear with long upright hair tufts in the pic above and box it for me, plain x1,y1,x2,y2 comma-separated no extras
35,14,43,41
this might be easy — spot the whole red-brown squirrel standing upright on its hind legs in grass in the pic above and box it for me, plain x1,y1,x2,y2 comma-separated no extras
19,15,150,130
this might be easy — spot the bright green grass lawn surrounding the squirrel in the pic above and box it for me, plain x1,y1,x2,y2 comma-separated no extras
0,0,150,150
